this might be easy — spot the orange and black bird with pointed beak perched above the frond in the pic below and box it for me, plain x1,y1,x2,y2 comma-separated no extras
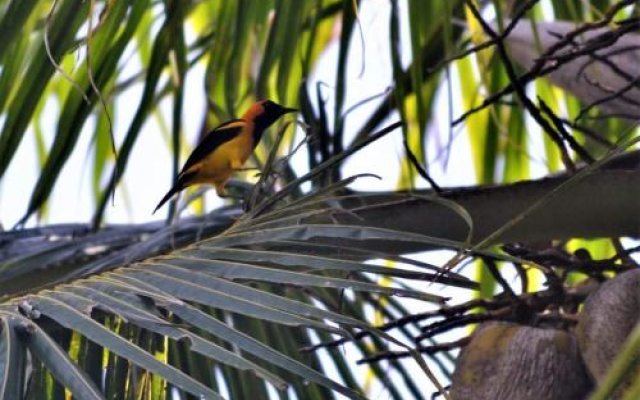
153,100,298,213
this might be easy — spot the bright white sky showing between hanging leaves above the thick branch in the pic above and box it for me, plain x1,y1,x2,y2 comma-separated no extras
0,0,474,229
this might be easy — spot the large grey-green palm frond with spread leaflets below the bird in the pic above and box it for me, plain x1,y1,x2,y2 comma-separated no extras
2,171,480,397
